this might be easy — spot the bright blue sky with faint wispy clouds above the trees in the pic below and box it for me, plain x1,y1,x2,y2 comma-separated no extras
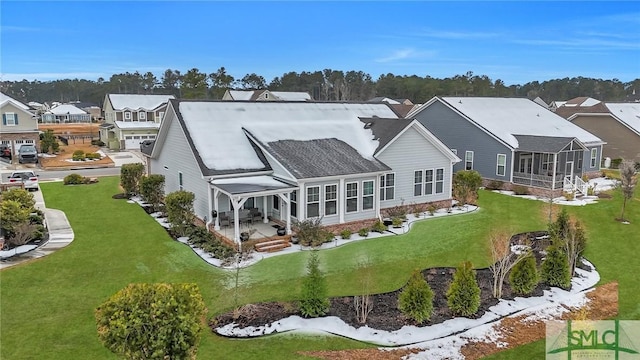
0,0,640,85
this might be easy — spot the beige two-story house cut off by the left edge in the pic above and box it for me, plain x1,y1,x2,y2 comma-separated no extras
0,93,40,154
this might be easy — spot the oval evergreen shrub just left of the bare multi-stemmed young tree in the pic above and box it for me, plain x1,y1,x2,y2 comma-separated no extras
447,261,480,316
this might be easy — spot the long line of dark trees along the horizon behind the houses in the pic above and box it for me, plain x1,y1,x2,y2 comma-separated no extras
0,67,640,105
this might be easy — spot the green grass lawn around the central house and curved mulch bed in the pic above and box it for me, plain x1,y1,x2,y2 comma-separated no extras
0,177,640,359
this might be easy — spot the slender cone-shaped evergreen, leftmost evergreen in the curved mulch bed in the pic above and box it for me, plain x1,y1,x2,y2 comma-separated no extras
300,250,330,317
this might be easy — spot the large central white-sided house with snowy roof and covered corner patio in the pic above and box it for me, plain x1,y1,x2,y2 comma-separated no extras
150,100,459,241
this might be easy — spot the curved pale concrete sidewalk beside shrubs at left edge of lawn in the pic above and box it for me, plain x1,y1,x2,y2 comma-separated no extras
0,190,75,270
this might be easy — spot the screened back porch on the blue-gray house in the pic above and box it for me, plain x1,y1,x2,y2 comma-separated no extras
512,135,587,191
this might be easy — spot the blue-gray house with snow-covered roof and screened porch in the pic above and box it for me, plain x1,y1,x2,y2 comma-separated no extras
409,97,604,191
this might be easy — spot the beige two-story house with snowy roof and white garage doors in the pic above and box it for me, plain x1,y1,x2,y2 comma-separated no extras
100,94,175,150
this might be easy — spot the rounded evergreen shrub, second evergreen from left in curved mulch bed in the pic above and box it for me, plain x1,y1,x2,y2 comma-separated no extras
398,270,433,324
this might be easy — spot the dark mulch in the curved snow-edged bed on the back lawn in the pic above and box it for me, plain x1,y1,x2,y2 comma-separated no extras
209,231,549,332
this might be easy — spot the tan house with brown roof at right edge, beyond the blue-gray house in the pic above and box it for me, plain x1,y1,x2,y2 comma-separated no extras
556,102,640,161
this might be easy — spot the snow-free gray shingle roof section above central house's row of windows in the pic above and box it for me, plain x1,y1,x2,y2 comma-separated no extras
266,139,390,179
